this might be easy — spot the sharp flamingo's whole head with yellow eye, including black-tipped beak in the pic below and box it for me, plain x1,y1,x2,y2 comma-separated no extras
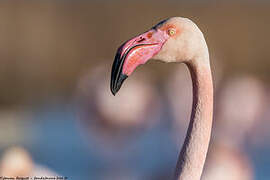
111,17,206,95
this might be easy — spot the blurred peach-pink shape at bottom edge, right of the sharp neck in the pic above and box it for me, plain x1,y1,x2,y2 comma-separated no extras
202,140,254,180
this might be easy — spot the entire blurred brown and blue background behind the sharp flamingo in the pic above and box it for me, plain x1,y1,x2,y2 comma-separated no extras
0,0,270,180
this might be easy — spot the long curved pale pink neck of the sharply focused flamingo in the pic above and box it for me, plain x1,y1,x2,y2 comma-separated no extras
175,56,213,180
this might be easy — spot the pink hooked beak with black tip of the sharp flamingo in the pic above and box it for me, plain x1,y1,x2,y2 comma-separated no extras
110,29,166,95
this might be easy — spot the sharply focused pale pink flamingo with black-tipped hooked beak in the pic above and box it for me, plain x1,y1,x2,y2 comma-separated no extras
111,17,213,180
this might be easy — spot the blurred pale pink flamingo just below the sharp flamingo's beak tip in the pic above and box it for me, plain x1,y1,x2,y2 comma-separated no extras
77,64,161,153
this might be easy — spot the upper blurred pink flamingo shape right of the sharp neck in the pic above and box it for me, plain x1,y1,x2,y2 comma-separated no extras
213,75,266,147
